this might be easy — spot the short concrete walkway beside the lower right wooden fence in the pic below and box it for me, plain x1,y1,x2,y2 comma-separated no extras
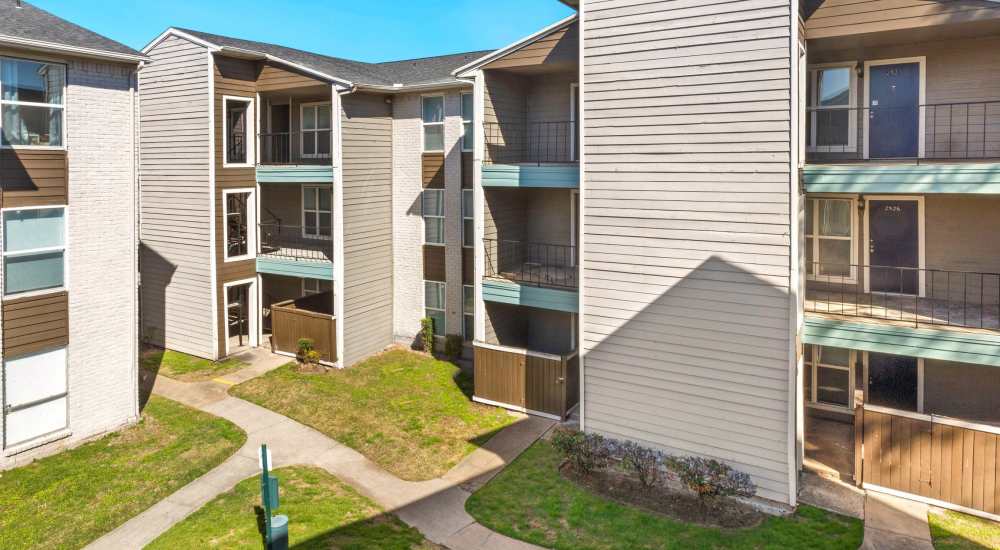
861,491,934,550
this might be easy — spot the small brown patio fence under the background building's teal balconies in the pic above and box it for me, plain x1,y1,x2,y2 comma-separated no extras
271,292,337,362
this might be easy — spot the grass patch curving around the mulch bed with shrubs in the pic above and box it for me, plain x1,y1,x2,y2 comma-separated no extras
466,441,863,550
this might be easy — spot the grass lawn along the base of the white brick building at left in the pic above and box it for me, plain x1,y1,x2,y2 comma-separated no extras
0,396,246,549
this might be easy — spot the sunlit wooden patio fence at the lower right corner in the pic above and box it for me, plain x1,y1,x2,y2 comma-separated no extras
855,405,1000,519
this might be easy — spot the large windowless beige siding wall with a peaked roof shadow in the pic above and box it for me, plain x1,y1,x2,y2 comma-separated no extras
582,0,795,502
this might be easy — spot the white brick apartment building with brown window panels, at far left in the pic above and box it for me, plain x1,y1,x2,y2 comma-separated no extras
0,0,143,469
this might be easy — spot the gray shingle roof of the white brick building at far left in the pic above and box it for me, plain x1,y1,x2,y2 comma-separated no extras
0,0,142,57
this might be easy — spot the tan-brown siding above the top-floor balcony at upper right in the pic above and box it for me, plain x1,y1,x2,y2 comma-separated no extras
806,0,1000,39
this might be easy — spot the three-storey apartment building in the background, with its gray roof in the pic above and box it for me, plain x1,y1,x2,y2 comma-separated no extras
140,28,484,366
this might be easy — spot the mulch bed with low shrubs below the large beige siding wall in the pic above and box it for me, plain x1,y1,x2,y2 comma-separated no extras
559,463,765,529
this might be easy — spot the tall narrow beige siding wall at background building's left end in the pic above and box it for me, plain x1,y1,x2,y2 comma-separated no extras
139,36,216,357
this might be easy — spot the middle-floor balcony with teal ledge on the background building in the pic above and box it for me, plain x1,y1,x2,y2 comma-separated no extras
257,223,333,280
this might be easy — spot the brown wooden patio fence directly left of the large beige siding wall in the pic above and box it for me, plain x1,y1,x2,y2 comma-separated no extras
473,343,580,419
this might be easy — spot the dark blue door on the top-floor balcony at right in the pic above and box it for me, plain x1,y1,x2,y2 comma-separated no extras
868,63,920,158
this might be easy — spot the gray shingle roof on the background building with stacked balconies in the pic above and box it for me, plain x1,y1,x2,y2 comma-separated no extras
177,28,492,86
